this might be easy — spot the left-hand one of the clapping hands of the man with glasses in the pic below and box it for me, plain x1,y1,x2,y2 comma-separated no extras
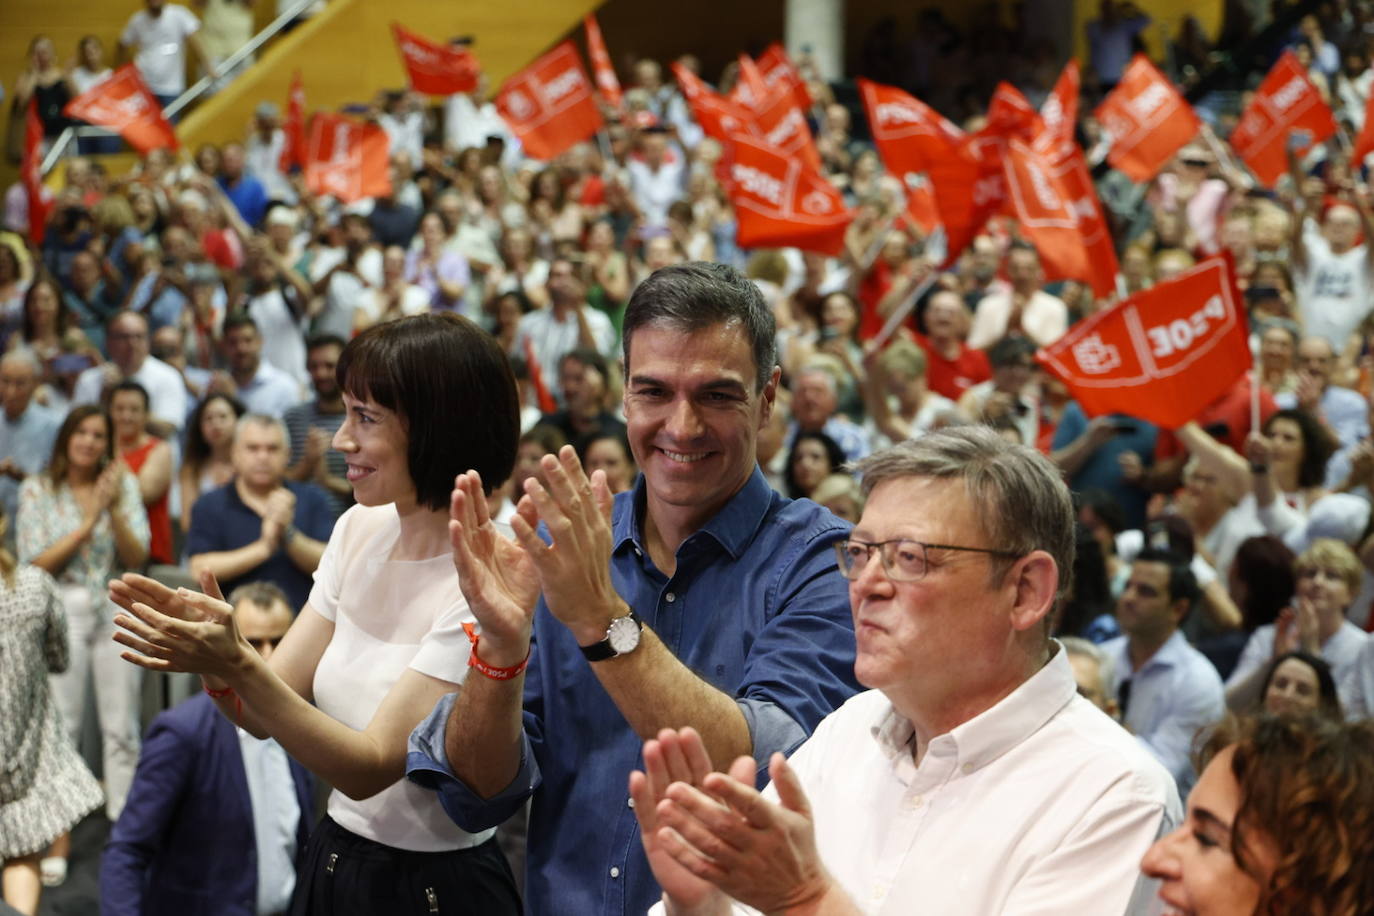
629,728,736,913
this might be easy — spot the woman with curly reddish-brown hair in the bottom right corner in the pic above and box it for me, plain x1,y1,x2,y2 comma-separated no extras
1140,715,1374,916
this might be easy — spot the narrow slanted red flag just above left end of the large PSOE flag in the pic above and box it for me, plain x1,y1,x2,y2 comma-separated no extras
1002,139,1088,280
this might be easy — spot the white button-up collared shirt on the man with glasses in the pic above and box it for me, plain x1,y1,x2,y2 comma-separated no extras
659,650,1182,916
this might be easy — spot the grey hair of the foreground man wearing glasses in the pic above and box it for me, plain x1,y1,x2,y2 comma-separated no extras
855,426,1074,603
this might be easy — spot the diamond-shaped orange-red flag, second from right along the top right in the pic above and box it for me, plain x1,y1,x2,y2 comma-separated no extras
1094,54,1202,181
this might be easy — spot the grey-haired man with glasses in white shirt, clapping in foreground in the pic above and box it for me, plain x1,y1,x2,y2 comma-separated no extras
631,427,1180,916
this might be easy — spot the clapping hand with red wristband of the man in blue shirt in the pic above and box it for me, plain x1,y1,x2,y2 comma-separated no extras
448,471,539,666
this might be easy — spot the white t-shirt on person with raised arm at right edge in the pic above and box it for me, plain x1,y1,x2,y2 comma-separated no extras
1293,220,1374,353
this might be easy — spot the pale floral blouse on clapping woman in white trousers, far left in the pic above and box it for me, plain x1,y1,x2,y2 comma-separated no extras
16,474,150,600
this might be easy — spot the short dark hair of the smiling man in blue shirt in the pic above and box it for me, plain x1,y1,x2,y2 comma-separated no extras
624,261,778,391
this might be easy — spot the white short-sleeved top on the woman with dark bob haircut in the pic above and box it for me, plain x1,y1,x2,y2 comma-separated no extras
309,505,495,853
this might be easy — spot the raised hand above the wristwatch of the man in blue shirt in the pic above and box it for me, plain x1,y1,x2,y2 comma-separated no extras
511,445,629,645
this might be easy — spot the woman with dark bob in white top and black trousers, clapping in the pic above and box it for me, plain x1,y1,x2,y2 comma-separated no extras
111,314,521,916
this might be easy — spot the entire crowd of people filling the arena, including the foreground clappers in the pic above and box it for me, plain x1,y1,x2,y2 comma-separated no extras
0,0,1374,916
